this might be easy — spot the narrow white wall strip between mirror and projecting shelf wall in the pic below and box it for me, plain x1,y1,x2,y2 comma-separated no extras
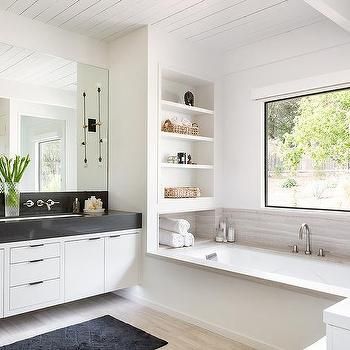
109,28,148,213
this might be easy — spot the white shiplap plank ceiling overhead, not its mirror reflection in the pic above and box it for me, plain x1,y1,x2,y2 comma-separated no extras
0,0,325,51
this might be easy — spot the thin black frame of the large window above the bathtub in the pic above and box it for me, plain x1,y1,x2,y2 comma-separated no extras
264,86,350,213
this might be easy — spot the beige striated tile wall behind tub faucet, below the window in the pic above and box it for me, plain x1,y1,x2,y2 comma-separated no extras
223,208,350,257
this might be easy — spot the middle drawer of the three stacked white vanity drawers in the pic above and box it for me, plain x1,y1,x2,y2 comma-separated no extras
10,258,60,287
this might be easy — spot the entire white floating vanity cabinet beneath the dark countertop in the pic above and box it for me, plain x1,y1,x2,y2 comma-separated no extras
0,229,141,318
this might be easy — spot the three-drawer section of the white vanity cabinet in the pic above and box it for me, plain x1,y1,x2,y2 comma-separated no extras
4,241,63,316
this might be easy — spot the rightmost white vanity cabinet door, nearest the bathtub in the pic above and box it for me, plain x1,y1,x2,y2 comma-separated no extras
106,234,140,292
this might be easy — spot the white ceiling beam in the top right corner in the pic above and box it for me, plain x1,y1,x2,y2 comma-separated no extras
304,0,350,32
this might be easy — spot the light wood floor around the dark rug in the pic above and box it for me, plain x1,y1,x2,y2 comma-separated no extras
0,294,253,350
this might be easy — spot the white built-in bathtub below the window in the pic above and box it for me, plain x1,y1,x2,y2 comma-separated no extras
157,242,350,297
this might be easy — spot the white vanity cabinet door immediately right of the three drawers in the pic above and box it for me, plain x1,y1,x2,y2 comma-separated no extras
64,238,105,301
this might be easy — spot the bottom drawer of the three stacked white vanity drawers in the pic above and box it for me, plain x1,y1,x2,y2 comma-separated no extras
10,279,60,310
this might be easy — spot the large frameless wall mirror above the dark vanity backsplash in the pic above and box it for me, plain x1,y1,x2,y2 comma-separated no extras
0,43,108,192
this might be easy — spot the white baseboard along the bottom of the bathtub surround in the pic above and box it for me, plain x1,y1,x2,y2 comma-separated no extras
114,290,283,350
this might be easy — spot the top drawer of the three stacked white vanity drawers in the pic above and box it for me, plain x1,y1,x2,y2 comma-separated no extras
11,243,60,264
